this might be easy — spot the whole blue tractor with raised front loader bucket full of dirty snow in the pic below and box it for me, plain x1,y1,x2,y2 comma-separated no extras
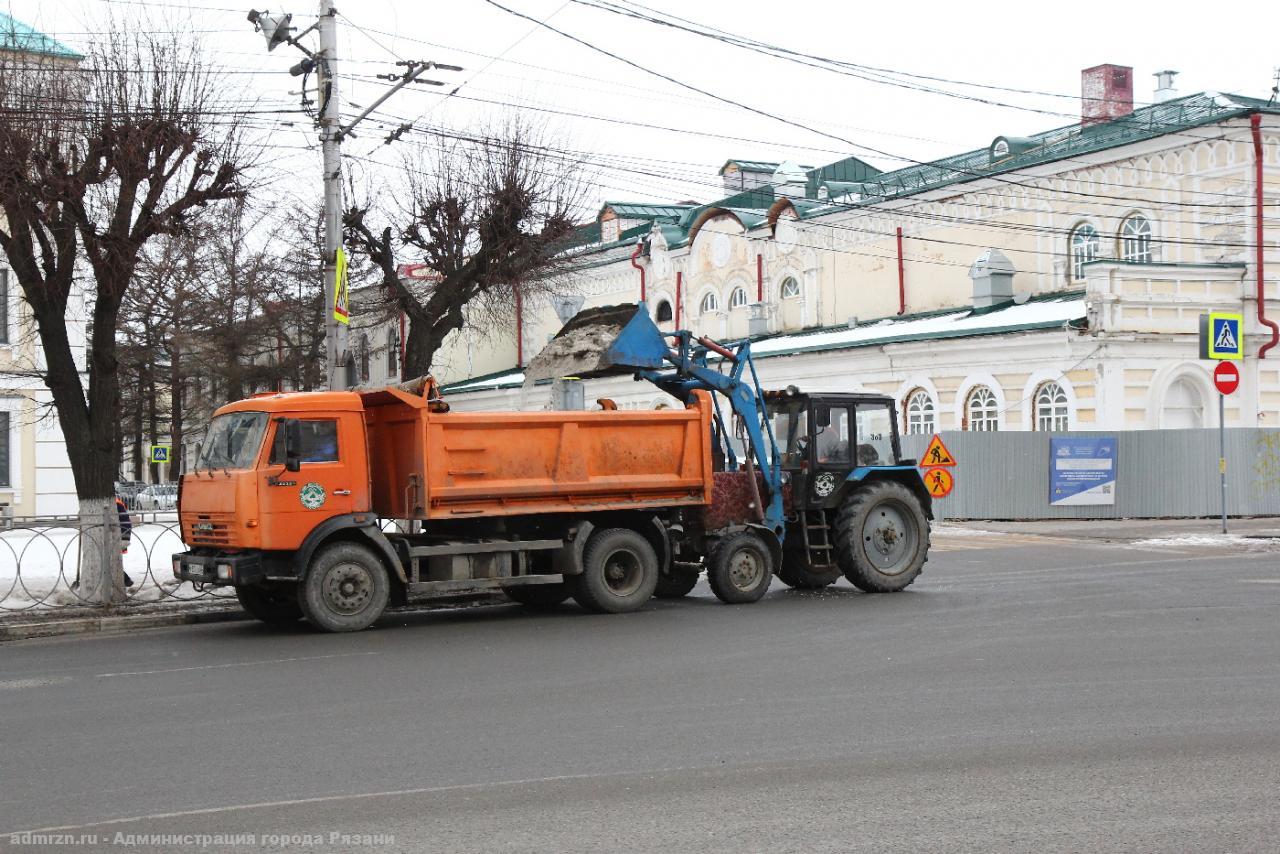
526,305,933,603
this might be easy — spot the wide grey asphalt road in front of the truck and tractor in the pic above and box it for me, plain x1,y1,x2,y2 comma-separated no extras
0,533,1280,853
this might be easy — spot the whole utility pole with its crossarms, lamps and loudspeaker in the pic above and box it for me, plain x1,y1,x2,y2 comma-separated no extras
248,0,462,389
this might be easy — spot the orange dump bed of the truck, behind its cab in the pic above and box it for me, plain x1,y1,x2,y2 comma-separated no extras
362,389,712,519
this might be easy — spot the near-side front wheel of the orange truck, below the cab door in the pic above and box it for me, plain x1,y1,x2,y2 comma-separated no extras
298,543,390,631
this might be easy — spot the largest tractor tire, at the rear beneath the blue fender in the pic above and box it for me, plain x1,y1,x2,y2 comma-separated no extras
836,480,929,593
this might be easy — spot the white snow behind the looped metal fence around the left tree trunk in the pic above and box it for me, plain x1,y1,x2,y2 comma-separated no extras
0,513,234,613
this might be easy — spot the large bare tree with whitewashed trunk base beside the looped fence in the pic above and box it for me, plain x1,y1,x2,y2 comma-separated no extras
0,26,246,603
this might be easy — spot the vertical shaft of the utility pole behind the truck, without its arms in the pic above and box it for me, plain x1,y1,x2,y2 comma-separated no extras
316,0,348,389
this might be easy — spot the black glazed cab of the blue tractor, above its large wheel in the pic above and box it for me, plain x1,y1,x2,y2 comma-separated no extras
765,385,915,510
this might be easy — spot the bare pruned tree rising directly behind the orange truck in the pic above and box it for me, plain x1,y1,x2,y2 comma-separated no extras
344,122,585,378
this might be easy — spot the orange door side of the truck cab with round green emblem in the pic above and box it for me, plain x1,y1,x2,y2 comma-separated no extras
259,412,369,549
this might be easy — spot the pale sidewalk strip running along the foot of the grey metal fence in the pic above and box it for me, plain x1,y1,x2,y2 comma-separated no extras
943,516,1280,543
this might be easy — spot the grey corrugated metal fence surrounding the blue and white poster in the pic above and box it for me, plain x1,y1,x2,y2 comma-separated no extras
902,428,1280,519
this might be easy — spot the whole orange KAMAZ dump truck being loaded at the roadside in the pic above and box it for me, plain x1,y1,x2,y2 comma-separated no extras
173,380,727,631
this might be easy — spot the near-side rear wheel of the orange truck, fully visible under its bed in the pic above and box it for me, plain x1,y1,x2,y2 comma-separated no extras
568,528,658,613
